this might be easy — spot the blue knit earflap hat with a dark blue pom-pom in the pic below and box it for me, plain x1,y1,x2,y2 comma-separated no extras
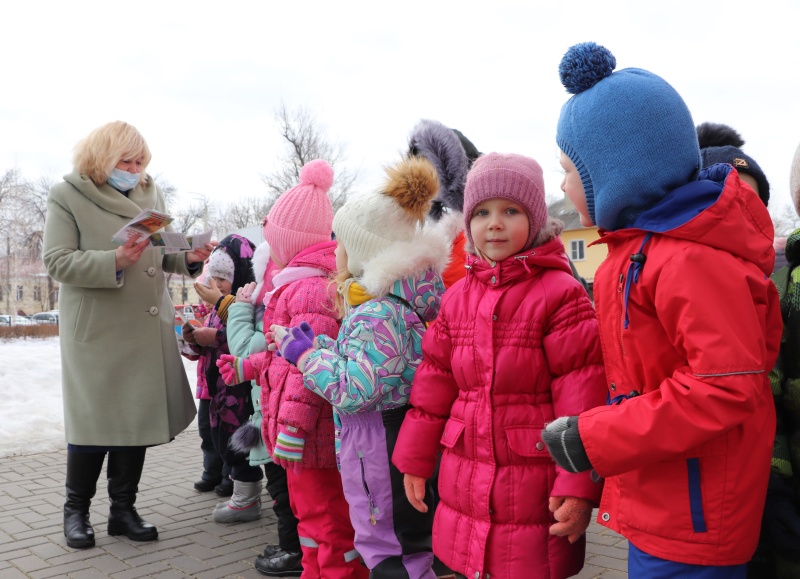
556,42,700,230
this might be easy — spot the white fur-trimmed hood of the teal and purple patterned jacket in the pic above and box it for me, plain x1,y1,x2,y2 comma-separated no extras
356,228,451,301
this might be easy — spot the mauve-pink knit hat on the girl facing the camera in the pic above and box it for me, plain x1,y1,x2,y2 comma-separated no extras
464,153,547,251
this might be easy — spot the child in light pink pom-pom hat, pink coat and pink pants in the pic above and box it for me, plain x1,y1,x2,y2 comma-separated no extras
220,160,369,579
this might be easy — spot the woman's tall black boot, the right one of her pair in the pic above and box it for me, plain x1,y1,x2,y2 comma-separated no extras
108,447,158,541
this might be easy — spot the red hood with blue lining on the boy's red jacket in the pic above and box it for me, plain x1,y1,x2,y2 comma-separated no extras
600,164,775,275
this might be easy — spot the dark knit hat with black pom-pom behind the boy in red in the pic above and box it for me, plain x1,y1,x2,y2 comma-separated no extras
697,123,769,206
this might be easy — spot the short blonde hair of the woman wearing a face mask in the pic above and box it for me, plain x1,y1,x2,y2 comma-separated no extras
72,121,151,185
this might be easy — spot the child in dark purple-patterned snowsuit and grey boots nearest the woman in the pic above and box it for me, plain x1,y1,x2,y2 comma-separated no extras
183,235,264,523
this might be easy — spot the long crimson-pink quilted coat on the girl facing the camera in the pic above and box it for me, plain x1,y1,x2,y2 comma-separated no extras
392,239,605,578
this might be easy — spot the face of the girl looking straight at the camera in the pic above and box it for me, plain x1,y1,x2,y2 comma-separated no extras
469,199,530,261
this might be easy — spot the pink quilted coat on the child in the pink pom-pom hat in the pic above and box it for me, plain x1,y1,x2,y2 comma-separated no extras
251,242,339,468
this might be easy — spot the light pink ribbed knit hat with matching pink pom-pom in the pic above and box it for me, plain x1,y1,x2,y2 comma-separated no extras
263,159,333,265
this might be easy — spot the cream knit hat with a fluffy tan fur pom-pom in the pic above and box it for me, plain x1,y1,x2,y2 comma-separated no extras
333,157,439,277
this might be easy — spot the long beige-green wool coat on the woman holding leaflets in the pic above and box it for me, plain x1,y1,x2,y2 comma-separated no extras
44,171,196,446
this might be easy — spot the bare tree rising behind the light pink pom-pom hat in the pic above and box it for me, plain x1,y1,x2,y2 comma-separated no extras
262,103,358,211
